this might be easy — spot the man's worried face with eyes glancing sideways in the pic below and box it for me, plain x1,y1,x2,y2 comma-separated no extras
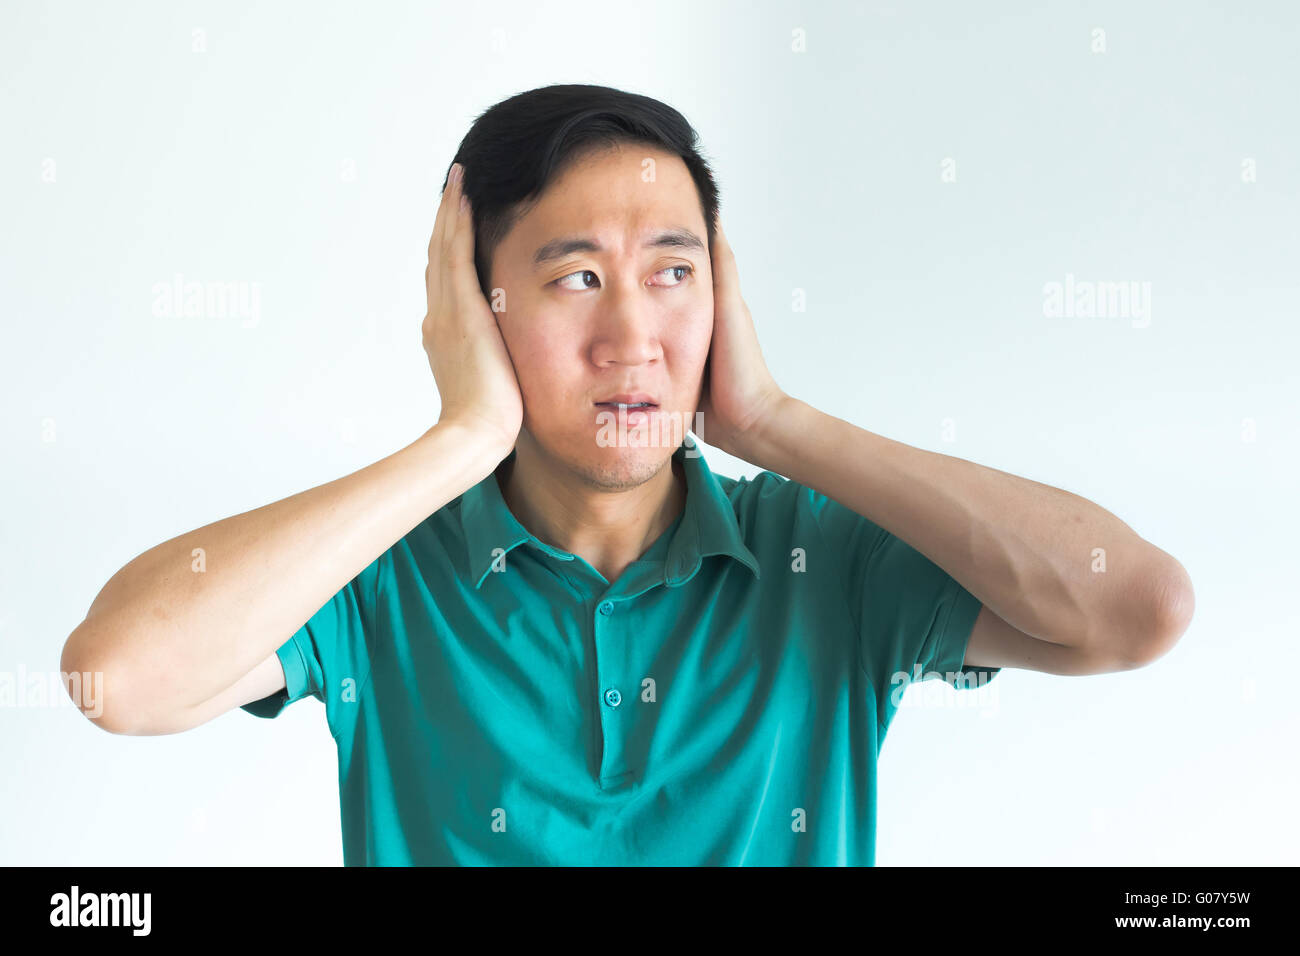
490,144,714,489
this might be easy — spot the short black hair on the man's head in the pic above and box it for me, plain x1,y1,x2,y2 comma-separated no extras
442,83,718,300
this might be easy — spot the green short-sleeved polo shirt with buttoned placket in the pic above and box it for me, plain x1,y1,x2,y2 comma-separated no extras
243,436,998,866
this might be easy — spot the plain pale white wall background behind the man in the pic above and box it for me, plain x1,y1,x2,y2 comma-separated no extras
0,0,1300,865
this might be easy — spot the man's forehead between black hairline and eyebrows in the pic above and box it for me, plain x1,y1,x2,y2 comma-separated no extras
501,143,705,261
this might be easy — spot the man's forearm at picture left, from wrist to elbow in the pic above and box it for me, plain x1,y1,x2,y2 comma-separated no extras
62,425,504,722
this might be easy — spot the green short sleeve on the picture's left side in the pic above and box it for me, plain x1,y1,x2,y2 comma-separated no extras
242,555,385,736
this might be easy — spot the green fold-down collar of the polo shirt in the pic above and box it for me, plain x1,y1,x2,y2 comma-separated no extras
460,434,759,588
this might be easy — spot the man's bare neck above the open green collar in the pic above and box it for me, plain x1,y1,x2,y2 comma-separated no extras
497,432,686,581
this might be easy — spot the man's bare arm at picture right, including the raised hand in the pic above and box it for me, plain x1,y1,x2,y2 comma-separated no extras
701,222,1196,674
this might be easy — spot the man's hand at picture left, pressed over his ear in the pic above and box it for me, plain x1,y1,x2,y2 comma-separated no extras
423,163,524,458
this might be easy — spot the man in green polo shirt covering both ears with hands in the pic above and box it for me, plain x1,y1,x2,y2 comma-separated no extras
64,86,1192,865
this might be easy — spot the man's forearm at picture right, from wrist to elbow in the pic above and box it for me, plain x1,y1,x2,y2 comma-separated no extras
746,398,1186,658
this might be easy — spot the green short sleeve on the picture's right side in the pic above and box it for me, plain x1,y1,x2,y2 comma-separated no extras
805,489,1001,724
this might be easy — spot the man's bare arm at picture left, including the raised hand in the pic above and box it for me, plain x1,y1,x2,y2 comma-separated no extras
61,160,523,735
